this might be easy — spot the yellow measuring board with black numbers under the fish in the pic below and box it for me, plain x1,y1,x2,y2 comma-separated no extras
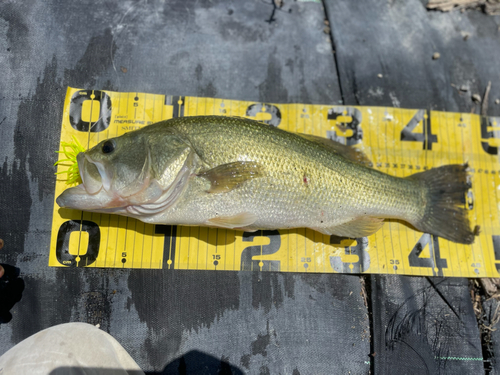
49,88,500,277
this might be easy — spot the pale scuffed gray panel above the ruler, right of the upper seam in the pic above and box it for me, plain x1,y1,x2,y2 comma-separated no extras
325,0,500,116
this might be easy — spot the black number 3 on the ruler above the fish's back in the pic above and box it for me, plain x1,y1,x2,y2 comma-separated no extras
326,107,363,146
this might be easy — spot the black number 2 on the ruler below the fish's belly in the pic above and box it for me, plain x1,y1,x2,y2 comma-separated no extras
240,230,281,271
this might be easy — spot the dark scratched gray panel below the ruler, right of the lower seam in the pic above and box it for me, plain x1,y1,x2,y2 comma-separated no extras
372,276,484,374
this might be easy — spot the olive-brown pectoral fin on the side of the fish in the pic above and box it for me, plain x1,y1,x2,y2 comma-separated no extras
198,161,264,193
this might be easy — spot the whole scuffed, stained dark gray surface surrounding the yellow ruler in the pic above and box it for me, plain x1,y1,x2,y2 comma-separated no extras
0,0,500,375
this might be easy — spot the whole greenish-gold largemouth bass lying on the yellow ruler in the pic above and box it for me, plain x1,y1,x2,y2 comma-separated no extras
56,116,479,244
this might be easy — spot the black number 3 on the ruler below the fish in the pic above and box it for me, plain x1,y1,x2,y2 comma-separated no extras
330,236,370,273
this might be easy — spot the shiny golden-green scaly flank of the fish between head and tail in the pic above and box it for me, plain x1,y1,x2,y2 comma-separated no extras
145,117,422,228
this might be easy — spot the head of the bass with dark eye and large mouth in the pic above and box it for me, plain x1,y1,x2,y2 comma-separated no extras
56,132,189,216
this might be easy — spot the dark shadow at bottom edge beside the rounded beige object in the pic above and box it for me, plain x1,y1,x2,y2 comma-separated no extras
50,350,244,375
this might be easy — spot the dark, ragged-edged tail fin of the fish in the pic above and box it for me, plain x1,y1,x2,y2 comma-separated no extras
408,164,479,244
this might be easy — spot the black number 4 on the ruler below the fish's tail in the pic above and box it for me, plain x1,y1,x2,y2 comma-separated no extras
408,233,448,276
